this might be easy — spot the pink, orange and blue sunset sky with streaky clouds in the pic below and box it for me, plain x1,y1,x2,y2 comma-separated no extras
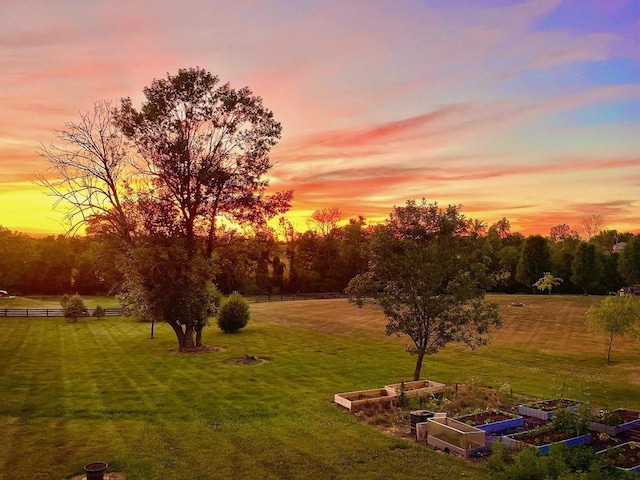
0,0,640,235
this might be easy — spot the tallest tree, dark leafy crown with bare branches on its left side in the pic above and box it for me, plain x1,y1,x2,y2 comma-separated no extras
41,68,291,351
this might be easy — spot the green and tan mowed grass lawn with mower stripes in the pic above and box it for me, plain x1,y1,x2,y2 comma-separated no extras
0,295,640,480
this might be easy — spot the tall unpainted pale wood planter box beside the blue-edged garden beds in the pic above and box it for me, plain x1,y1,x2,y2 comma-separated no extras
427,417,485,457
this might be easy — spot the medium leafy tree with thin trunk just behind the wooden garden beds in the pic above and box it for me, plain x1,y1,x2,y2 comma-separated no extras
347,200,501,380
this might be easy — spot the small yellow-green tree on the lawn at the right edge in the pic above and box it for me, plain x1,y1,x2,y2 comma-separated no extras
587,295,640,364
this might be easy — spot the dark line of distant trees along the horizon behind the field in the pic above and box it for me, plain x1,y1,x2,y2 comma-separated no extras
0,214,640,295
